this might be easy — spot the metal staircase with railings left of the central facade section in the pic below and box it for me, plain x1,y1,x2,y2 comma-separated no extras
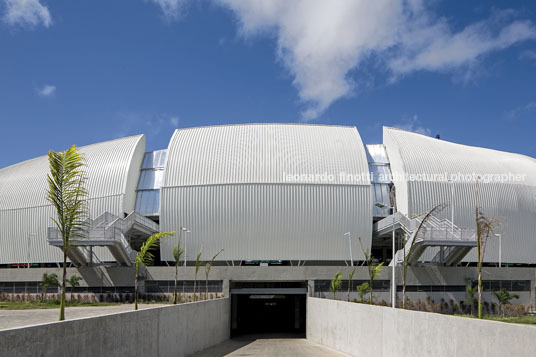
48,212,159,266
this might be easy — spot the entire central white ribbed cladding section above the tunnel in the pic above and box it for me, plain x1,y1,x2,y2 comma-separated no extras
160,124,372,260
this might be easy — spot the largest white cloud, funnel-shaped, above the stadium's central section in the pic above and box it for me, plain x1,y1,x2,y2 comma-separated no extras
216,0,536,120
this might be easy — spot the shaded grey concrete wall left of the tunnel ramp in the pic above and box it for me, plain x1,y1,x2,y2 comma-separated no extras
0,299,231,356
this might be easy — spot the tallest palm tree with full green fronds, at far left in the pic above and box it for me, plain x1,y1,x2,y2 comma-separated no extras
46,145,88,321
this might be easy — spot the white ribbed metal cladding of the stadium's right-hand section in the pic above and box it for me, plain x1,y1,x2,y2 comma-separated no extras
383,128,536,263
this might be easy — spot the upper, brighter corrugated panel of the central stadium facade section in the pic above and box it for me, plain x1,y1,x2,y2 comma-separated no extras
164,124,369,187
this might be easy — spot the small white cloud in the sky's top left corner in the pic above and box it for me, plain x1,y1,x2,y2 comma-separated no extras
3,0,52,28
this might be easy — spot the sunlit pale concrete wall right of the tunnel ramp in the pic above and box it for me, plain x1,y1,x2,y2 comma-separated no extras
307,297,536,357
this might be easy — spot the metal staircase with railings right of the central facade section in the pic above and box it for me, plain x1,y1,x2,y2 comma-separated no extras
374,212,477,266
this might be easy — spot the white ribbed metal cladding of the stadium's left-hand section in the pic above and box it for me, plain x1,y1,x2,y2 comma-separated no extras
0,135,145,264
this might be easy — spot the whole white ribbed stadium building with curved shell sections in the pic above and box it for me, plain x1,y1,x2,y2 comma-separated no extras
0,124,536,330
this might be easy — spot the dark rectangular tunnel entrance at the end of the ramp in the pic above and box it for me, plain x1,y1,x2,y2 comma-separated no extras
231,282,307,337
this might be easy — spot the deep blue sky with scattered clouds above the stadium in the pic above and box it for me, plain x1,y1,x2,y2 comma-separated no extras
0,0,536,167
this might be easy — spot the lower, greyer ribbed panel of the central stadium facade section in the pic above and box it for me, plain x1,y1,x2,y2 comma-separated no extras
160,184,372,261
